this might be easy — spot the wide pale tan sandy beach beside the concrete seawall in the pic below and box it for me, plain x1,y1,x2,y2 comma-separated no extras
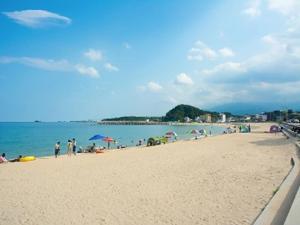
0,124,295,225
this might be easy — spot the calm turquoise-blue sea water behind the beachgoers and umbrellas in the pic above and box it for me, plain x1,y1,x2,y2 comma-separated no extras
0,122,224,158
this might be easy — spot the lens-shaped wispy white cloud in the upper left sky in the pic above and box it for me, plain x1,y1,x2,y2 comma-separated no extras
2,10,72,28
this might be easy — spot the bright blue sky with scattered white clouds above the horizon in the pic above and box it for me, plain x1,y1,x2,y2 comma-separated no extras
0,0,300,121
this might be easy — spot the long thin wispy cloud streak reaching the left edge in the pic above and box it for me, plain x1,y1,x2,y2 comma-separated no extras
0,57,99,78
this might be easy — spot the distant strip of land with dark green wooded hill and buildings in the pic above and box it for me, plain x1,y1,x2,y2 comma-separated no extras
101,104,300,124
